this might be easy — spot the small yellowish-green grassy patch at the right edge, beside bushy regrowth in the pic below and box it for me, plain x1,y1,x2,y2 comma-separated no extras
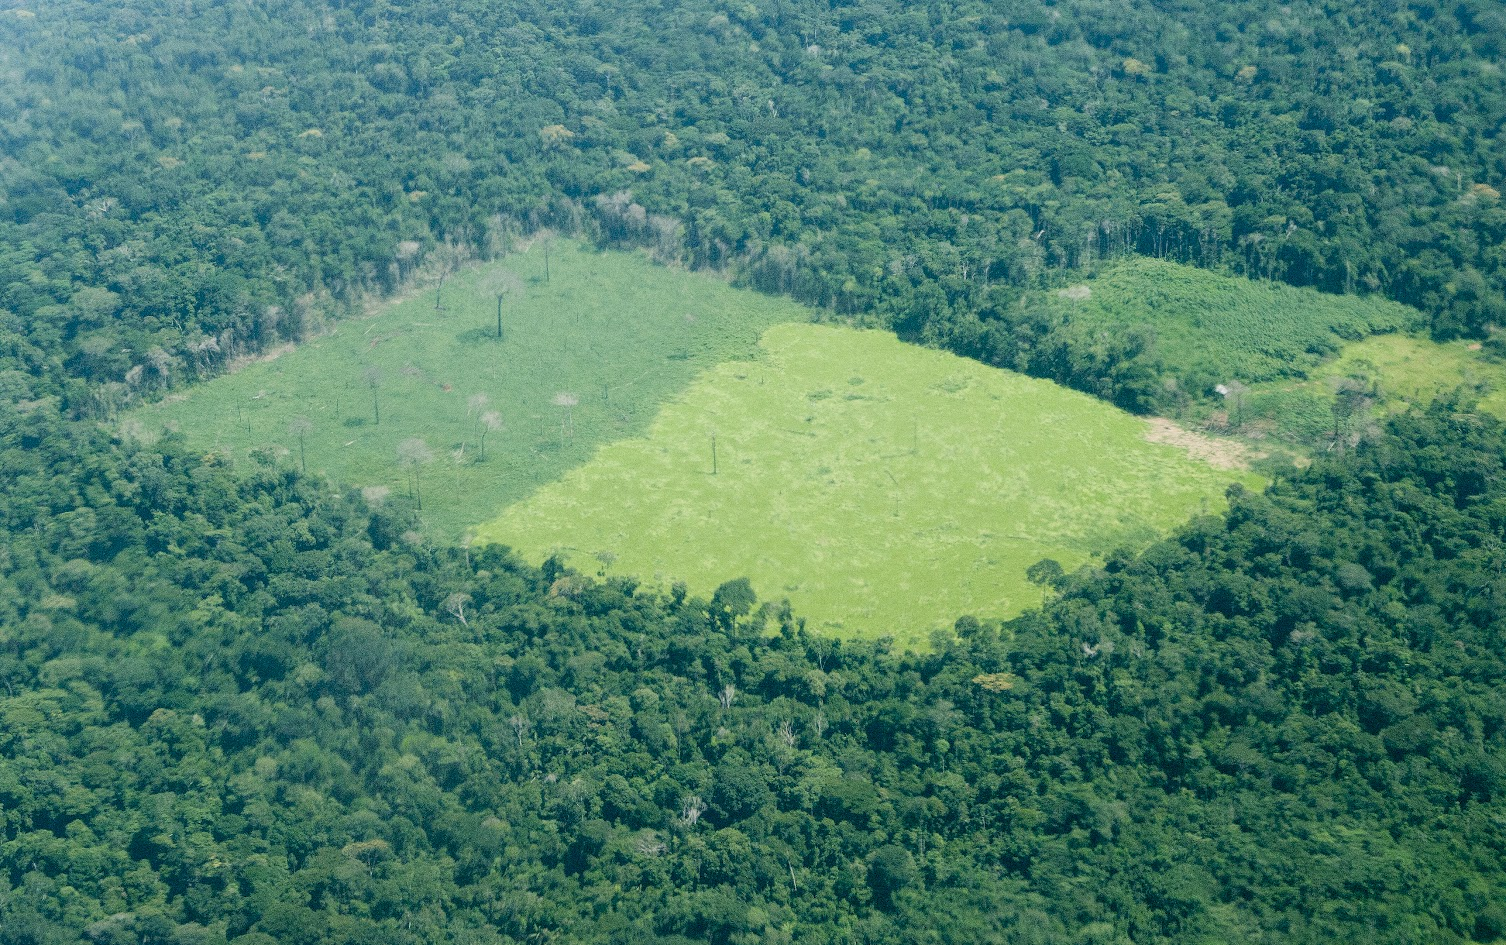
1244,333,1506,442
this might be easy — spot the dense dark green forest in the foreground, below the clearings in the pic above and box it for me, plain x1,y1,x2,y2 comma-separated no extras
0,404,1506,945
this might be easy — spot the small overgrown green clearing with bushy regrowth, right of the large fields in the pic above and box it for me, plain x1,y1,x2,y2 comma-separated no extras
1051,258,1417,384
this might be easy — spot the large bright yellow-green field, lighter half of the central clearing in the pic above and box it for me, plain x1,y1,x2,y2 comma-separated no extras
476,324,1258,644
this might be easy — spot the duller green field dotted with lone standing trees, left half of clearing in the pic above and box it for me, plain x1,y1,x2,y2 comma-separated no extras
130,243,809,537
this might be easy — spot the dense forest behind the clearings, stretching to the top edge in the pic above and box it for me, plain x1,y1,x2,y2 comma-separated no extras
0,0,1506,411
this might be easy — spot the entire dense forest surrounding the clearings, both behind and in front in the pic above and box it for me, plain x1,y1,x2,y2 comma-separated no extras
0,0,1506,945
